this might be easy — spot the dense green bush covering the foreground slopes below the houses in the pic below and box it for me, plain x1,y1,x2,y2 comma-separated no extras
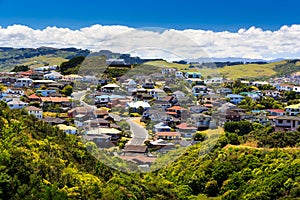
0,102,300,200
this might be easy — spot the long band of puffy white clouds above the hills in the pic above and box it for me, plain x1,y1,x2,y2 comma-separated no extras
0,24,300,60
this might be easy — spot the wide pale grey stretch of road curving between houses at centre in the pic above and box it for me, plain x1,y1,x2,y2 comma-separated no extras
126,118,148,145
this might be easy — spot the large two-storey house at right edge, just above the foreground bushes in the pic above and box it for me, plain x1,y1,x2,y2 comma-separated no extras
275,116,300,131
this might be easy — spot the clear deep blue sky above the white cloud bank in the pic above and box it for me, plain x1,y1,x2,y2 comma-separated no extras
0,0,300,31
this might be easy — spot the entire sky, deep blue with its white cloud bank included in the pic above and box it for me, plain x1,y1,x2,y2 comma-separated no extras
0,0,300,59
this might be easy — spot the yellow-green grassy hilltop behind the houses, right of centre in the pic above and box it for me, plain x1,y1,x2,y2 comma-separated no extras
147,61,290,79
